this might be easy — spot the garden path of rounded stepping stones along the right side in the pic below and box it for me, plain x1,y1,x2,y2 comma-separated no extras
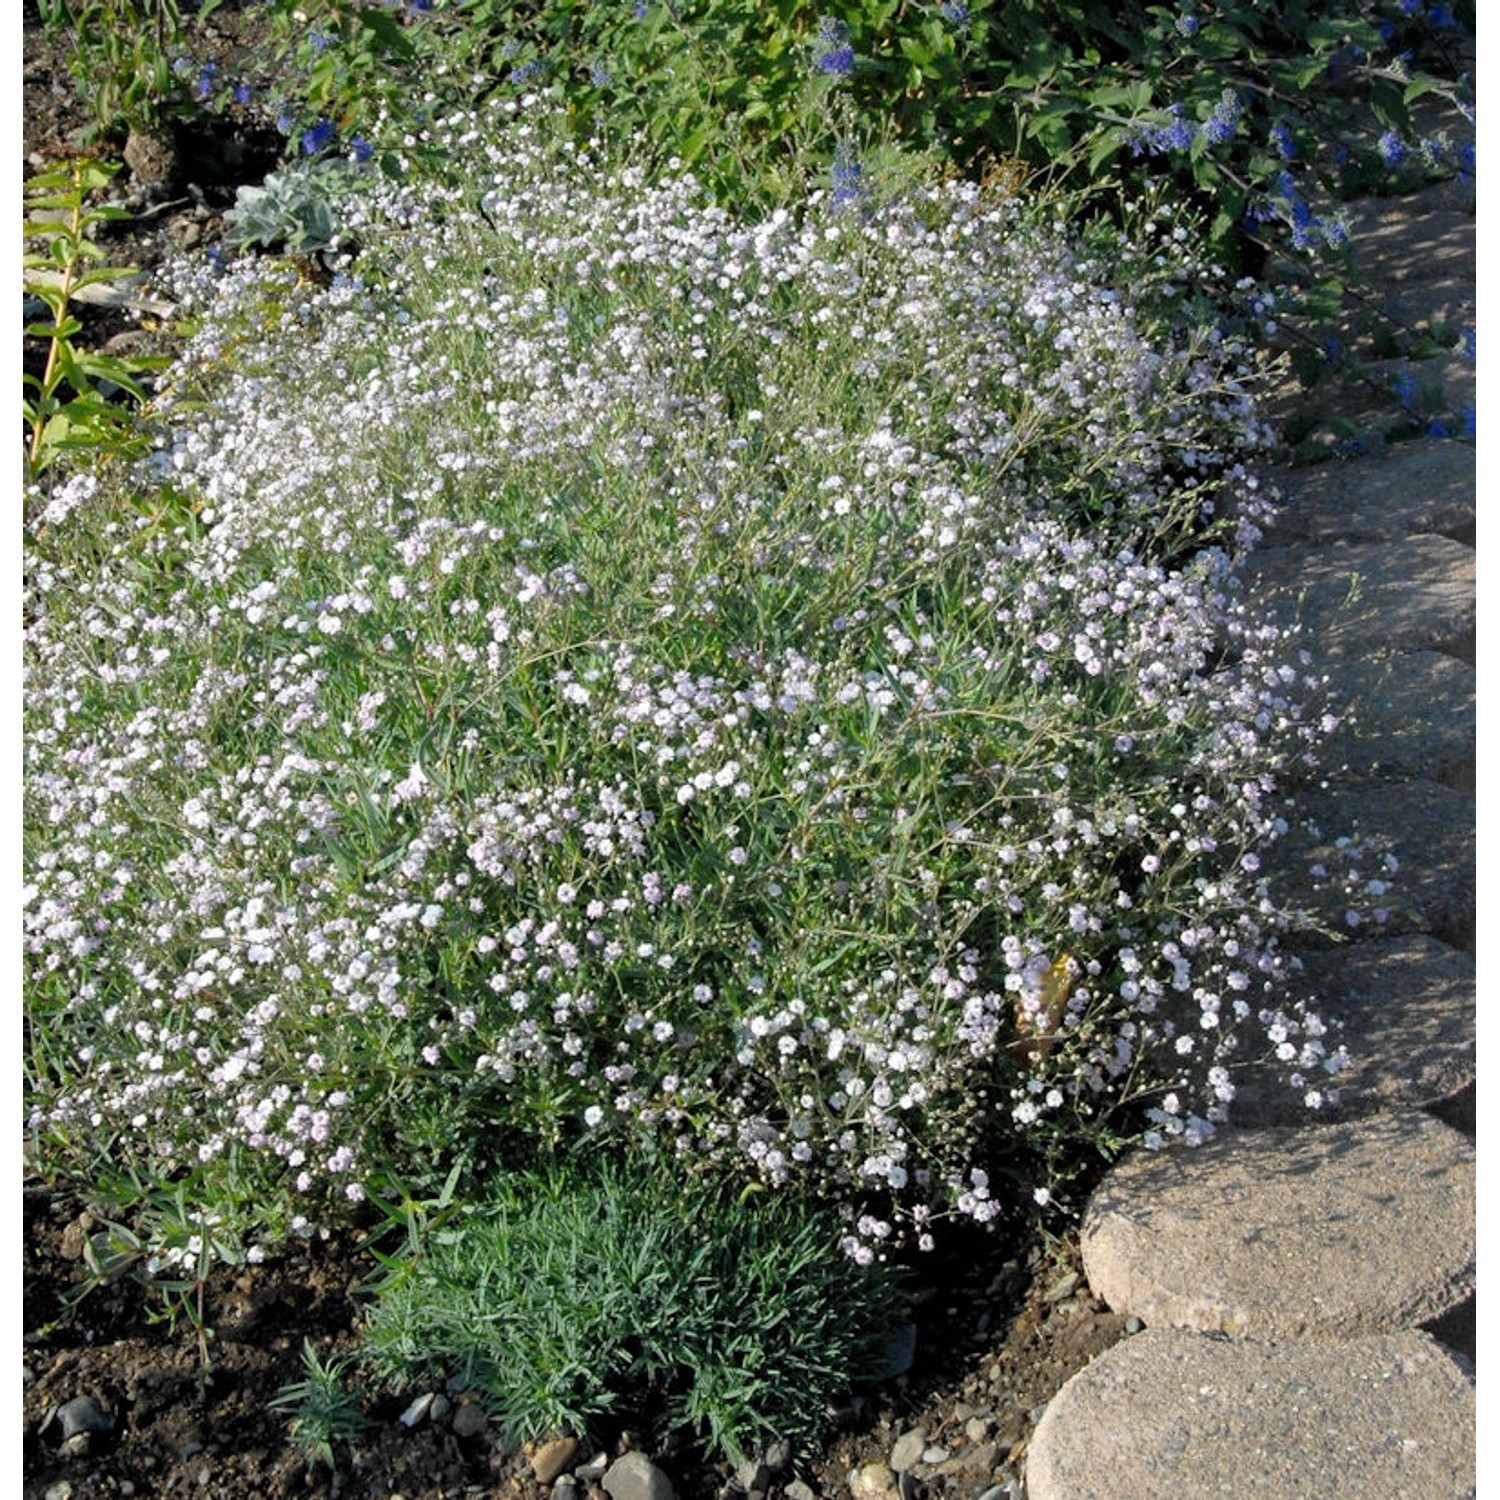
1026,164,1476,1500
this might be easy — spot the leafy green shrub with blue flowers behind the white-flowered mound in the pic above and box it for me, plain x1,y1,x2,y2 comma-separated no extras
249,0,1472,267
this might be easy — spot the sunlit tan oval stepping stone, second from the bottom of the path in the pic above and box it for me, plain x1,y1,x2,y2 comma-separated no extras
1082,1112,1475,1340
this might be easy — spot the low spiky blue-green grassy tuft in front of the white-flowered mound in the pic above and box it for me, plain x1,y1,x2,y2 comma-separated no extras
365,1164,906,1460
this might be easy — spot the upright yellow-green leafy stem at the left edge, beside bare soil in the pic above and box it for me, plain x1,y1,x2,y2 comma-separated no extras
21,158,165,492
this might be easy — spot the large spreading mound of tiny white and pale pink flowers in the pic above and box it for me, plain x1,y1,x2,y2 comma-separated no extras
24,104,1341,1262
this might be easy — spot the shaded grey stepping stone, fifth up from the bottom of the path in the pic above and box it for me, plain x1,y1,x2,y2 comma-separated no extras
1319,651,1476,797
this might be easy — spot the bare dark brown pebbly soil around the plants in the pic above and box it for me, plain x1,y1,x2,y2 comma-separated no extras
21,11,1122,1500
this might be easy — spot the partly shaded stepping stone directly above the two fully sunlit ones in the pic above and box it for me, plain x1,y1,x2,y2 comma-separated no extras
1232,933,1478,1134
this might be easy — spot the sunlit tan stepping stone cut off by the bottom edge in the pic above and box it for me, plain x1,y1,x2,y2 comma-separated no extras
1026,1329,1476,1500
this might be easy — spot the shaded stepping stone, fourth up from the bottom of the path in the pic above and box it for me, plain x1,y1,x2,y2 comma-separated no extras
1266,782,1478,953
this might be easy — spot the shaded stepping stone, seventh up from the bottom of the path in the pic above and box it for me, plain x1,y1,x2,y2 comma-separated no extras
1266,438,1476,546
